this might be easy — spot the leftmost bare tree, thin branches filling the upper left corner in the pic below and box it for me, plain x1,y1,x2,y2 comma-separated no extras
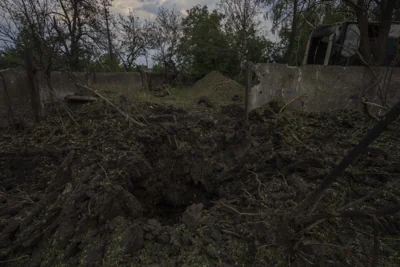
0,0,59,77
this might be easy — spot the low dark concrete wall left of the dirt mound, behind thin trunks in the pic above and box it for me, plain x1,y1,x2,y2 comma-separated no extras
0,69,165,128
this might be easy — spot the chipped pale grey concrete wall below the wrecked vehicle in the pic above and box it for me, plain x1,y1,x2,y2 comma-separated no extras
248,64,400,111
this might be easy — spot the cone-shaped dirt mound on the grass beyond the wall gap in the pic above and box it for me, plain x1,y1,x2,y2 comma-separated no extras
190,71,245,104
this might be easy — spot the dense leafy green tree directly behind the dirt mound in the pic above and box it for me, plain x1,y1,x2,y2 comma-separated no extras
180,5,240,76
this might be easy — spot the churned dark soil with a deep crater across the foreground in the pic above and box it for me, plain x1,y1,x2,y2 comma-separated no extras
0,98,400,267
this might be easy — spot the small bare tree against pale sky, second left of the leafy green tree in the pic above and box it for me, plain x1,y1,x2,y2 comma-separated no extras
115,11,153,71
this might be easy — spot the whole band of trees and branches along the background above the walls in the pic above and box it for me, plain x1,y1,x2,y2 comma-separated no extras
0,0,400,77
